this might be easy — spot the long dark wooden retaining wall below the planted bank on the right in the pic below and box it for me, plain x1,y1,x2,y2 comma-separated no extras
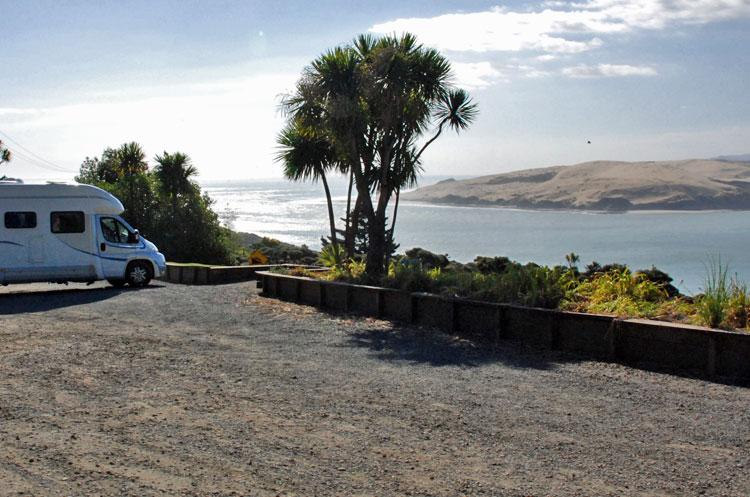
257,271,750,380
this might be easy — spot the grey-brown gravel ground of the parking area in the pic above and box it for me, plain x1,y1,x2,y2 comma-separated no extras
0,283,750,496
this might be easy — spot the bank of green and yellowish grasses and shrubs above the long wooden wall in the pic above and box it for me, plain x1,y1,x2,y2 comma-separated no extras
280,249,750,331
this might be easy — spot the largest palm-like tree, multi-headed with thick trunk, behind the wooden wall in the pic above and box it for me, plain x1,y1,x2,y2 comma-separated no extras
282,34,476,277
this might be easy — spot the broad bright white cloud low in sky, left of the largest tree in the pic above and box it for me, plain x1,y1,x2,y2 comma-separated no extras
0,73,298,179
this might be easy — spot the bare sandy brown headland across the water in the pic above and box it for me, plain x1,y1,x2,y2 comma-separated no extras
402,156,750,211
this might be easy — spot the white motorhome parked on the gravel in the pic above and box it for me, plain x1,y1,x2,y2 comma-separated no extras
0,181,166,287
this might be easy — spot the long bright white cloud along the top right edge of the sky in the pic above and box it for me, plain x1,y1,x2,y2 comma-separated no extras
370,0,750,53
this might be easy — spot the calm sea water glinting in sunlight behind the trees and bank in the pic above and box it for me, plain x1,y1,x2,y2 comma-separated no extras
203,177,750,293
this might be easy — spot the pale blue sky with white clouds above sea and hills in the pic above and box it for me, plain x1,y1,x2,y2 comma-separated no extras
0,0,750,180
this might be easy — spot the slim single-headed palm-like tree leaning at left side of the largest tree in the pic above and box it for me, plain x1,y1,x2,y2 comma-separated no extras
276,121,338,250
